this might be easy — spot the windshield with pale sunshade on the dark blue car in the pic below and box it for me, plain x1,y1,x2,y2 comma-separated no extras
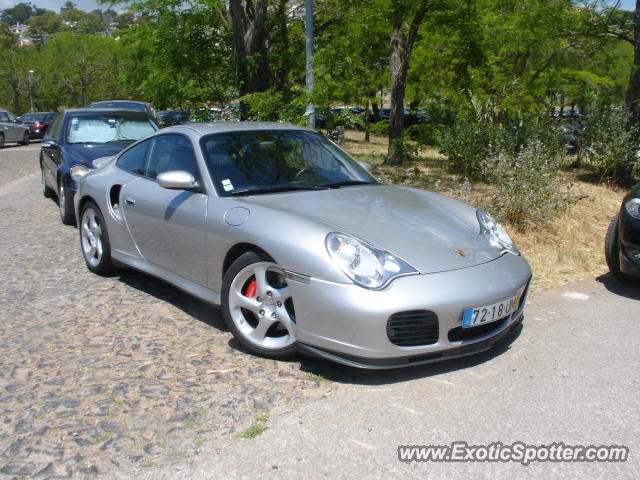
66,113,157,143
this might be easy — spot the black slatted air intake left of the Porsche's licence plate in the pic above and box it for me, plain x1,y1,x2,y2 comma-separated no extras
387,310,438,347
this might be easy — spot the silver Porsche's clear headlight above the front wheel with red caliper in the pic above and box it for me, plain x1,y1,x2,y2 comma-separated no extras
325,232,417,288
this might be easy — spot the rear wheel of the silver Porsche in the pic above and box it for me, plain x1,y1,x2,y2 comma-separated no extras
78,202,115,275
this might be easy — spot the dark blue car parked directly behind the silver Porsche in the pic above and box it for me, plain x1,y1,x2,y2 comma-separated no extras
40,108,158,225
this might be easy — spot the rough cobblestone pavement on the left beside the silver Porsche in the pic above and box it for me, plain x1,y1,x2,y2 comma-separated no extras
0,144,332,479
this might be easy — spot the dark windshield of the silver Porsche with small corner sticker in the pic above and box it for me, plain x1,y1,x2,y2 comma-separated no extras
200,130,377,196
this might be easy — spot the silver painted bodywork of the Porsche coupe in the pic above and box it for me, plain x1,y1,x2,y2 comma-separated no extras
75,123,531,366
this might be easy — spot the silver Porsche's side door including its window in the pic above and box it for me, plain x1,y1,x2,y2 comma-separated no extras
121,134,207,286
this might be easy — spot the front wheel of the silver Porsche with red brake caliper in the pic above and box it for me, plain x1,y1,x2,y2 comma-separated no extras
222,252,297,359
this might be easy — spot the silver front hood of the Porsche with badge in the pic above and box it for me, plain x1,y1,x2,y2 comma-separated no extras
242,185,501,273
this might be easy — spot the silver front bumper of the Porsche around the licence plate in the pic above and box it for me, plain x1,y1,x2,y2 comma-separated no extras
289,254,531,368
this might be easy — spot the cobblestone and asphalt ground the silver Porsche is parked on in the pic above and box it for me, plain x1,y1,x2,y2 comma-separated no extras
0,144,640,480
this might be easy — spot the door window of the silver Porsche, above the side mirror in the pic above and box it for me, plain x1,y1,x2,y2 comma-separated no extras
146,135,200,181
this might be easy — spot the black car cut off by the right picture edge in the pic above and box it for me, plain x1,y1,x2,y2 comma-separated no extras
604,183,640,282
